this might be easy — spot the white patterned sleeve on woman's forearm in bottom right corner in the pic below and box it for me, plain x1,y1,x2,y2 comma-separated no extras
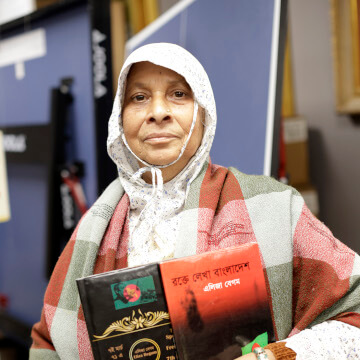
286,320,360,360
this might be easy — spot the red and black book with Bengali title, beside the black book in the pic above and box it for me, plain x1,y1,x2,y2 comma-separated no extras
160,243,275,360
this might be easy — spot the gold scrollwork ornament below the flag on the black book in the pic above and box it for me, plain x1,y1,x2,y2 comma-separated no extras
93,309,170,341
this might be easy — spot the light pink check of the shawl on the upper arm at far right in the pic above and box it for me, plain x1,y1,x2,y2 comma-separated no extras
294,205,355,280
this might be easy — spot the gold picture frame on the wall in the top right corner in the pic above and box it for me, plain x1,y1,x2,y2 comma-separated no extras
330,0,360,115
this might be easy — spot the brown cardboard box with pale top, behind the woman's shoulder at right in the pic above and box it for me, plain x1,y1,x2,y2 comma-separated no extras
283,117,309,187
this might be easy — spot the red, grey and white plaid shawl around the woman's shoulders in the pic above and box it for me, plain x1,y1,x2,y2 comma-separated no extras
30,164,360,360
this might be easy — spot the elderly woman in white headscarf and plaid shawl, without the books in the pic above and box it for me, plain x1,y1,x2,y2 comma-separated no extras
30,43,360,360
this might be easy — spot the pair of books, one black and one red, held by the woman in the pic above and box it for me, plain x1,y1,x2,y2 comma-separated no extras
77,243,275,360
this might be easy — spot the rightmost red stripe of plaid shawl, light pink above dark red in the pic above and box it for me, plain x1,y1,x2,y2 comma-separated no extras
291,205,359,334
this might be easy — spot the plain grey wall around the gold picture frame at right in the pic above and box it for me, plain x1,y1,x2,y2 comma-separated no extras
289,0,360,253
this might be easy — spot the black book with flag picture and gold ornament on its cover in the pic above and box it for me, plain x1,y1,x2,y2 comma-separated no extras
77,264,177,360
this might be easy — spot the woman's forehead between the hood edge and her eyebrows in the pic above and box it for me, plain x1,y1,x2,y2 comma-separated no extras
127,61,190,88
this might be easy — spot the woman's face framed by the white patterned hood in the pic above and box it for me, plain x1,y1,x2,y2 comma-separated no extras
122,62,203,180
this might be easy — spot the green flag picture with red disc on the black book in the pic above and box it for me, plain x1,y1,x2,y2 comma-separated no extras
110,276,157,310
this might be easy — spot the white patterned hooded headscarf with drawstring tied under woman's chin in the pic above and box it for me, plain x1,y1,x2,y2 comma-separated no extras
107,43,216,266
